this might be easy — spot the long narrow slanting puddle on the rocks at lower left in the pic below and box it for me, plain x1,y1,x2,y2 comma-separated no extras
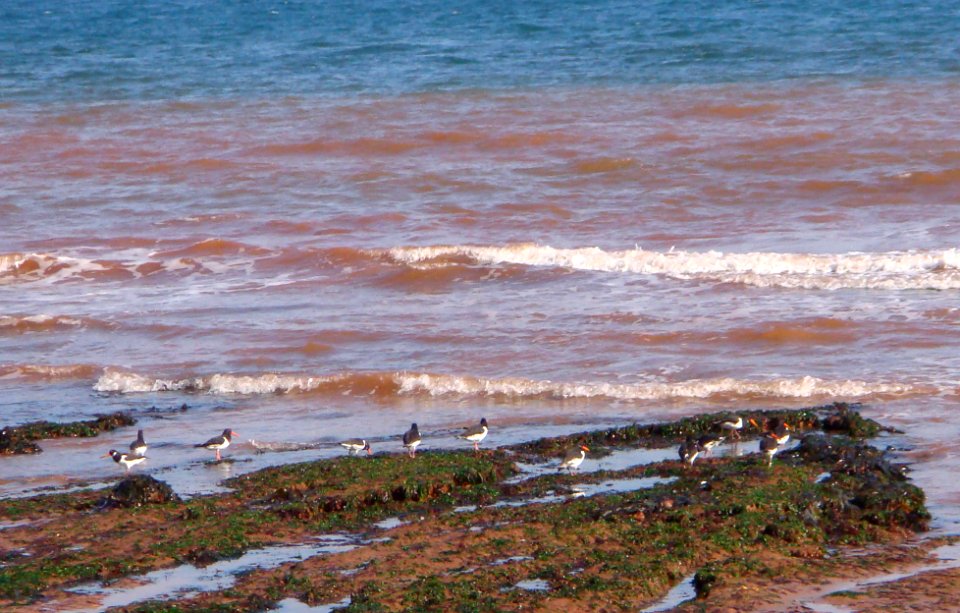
68,534,362,613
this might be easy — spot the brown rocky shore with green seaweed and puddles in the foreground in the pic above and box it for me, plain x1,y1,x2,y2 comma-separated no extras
0,403,950,611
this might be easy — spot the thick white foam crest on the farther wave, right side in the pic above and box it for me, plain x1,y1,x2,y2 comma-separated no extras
381,243,960,289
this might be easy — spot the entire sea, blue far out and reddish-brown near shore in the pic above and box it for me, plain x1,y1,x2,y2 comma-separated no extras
0,0,960,533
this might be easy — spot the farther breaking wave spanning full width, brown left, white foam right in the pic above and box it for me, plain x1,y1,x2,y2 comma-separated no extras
9,239,960,290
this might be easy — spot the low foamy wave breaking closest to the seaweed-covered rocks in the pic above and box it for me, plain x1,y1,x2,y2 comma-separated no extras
94,369,935,401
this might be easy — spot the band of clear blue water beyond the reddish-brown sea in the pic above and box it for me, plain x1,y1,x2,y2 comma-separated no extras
0,0,960,101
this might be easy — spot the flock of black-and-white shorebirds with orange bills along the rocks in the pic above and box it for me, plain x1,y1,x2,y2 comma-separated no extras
103,416,790,472
